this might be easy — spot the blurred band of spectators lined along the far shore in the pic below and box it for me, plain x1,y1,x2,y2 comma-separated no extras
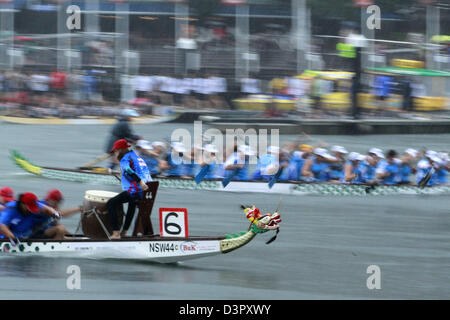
0,66,436,118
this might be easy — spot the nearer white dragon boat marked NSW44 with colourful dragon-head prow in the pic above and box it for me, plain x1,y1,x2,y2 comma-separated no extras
0,181,281,263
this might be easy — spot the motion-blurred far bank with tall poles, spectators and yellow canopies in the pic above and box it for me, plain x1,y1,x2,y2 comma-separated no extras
0,0,450,118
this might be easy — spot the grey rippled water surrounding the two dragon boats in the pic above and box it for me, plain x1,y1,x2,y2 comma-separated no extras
0,123,450,300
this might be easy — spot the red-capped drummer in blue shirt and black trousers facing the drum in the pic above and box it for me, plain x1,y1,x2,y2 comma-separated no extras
106,139,152,239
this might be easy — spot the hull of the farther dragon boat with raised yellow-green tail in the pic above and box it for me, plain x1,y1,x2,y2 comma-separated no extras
11,151,450,196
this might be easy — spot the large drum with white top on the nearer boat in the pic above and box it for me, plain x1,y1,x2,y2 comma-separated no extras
81,190,124,239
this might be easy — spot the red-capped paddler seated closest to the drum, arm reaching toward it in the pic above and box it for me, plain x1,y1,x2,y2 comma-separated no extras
30,189,81,240
